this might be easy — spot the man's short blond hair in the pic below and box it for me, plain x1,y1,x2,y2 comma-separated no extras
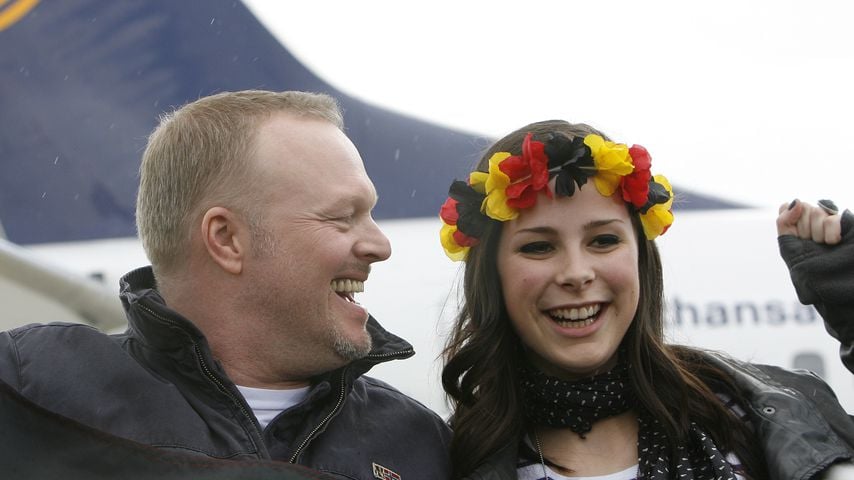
136,90,343,272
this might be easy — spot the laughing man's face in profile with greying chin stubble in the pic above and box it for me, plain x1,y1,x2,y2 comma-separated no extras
243,114,391,374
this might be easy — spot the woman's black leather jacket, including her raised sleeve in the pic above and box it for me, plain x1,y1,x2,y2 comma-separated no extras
466,211,854,480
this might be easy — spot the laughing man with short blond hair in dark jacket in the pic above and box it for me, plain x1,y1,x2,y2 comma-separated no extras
0,91,450,479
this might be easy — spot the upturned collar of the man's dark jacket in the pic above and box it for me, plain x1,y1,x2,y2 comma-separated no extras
120,266,415,376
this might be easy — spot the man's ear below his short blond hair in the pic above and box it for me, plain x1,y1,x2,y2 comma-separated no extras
201,207,249,275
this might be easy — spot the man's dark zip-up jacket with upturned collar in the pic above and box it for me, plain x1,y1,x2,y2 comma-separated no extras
0,268,450,480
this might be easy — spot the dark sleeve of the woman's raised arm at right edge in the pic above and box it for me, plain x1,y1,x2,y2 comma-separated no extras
777,210,854,373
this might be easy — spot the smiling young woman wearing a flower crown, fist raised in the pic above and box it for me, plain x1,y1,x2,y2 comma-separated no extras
440,121,854,480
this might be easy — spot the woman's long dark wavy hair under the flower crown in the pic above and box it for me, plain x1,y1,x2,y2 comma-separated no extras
442,120,765,478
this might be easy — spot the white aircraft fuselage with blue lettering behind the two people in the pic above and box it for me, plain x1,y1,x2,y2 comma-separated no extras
0,210,854,414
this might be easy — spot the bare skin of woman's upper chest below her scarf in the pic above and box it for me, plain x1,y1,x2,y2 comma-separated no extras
531,410,638,476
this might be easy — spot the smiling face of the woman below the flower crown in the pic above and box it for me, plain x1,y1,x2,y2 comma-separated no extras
498,183,640,379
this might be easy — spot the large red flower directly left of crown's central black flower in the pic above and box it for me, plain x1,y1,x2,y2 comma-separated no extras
498,133,551,209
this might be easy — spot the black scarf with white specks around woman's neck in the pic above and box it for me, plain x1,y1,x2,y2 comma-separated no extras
520,362,736,480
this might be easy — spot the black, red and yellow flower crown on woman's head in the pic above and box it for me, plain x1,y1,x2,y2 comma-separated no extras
439,133,673,261
